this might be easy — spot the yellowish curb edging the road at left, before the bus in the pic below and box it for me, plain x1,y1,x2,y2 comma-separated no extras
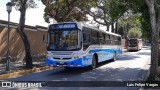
0,66,53,80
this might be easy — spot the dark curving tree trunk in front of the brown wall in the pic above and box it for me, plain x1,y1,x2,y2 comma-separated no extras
17,0,33,69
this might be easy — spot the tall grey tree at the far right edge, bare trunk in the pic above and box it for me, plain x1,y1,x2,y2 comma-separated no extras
145,0,160,76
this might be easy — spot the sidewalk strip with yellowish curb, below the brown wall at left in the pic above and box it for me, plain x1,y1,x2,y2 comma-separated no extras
0,62,52,80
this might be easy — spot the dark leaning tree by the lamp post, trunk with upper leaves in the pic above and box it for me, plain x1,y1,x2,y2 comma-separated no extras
11,0,36,68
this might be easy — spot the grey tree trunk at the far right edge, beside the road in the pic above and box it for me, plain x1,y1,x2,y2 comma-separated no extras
146,0,159,76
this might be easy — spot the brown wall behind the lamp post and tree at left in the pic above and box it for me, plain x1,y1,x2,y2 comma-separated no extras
0,26,47,62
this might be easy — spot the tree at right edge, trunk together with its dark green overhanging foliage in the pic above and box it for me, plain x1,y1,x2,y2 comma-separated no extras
110,0,160,76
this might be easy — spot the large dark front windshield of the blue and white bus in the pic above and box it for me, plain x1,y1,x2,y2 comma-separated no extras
48,30,80,51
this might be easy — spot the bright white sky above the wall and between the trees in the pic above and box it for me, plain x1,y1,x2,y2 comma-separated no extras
0,0,106,30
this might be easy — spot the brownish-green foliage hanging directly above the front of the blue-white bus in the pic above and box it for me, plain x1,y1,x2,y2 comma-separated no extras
41,0,95,22
